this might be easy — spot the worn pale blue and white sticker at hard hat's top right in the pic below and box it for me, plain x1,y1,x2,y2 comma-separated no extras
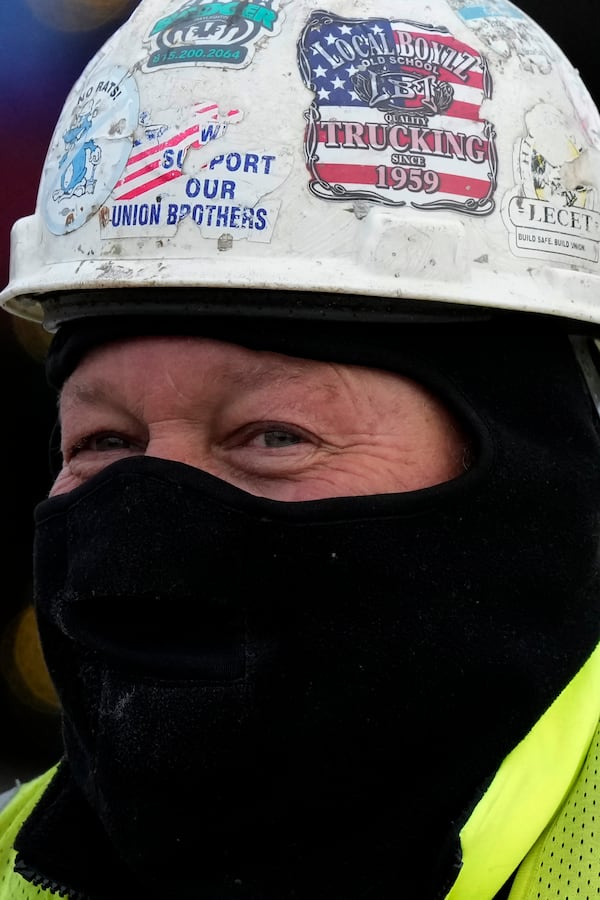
448,0,554,75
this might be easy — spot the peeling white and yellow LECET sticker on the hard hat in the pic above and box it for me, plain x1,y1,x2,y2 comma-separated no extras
502,104,600,263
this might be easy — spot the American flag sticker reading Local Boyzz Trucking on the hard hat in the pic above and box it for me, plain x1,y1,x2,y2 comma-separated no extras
298,11,497,215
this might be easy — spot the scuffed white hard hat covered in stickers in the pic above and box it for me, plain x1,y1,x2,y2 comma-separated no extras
0,0,600,330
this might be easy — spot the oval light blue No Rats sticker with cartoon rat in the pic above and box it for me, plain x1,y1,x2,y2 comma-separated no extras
40,67,139,234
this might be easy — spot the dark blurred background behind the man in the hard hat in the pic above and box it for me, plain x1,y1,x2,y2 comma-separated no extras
0,0,600,790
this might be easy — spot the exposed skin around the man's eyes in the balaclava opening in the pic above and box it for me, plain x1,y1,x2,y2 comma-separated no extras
52,337,468,501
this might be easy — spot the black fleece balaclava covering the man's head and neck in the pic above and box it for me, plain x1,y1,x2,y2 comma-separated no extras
11,318,600,900
